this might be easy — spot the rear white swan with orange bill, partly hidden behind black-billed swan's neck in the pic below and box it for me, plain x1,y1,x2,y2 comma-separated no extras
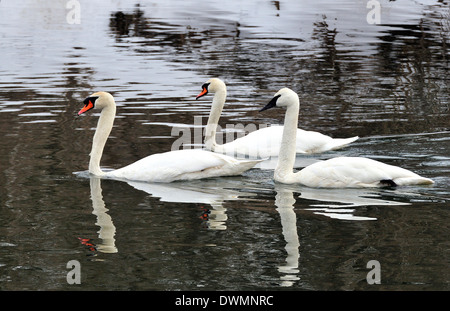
196,78,359,158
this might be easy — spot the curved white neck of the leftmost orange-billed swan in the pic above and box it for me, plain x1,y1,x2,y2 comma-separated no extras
89,103,116,176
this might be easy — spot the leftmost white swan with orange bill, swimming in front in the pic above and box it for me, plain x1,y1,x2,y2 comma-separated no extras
78,92,260,182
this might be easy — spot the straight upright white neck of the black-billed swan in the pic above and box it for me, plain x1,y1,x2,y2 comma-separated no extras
274,97,300,183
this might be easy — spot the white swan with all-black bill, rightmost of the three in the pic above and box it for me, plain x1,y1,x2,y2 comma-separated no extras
260,88,434,188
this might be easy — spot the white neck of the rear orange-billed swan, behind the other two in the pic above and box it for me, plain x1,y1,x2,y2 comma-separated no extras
205,87,227,151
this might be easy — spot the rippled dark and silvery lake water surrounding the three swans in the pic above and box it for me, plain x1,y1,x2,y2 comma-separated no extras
0,0,450,290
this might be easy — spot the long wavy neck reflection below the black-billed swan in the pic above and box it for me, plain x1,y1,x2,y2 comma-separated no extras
275,187,300,286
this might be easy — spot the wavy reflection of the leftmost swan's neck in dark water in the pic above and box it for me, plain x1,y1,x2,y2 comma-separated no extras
90,177,117,253
